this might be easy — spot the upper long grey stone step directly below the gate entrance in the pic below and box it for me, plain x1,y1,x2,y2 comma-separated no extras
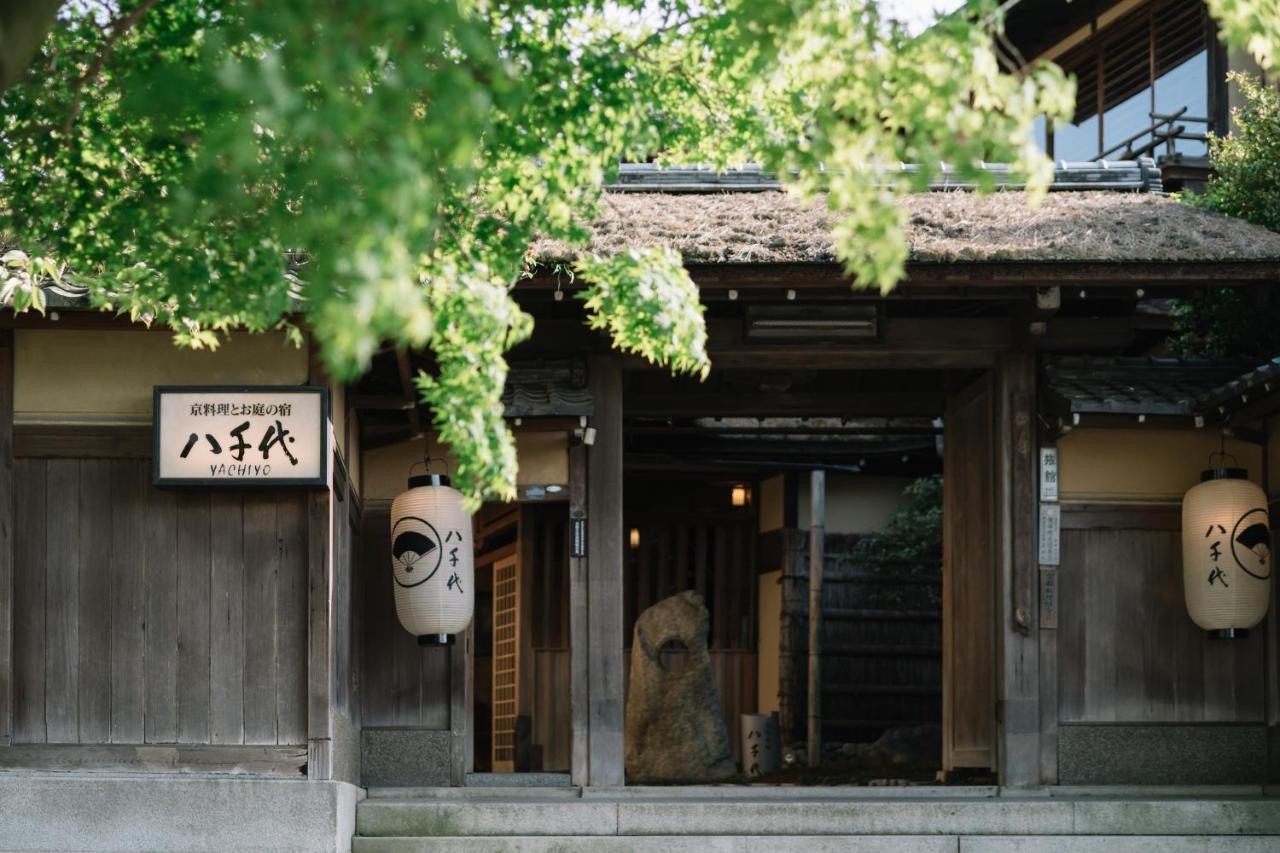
356,792,1280,835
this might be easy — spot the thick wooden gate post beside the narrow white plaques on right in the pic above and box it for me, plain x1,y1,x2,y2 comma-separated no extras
996,351,1041,785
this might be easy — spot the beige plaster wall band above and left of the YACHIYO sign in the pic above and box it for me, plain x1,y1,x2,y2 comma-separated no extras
14,329,310,424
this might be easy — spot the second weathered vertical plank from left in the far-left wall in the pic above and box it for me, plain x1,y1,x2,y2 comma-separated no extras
45,460,81,743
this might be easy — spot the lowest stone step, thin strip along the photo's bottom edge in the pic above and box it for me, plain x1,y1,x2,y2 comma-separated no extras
352,835,1277,853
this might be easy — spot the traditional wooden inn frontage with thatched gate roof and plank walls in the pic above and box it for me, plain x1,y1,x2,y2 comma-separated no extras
0,159,1280,849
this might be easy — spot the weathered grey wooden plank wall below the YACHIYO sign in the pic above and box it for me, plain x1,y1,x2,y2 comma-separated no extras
13,457,307,745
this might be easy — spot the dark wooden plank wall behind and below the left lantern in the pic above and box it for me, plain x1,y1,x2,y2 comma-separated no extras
357,506,449,729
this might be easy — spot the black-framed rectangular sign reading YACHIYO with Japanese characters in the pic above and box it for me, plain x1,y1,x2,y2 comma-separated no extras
152,386,329,485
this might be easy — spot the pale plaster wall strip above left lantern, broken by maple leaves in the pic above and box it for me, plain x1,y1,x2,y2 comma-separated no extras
364,432,568,501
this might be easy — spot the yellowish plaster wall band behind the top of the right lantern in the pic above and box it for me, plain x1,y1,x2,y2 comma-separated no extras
1057,428,1262,503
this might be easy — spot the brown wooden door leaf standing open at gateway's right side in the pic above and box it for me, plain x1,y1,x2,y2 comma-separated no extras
942,374,1000,770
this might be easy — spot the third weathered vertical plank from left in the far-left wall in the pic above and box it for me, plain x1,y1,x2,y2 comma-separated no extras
77,460,114,743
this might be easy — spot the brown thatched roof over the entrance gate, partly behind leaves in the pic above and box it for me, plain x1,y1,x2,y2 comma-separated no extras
534,191,1280,264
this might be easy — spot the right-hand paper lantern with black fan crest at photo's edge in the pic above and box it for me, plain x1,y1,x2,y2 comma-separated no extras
1183,467,1271,637
